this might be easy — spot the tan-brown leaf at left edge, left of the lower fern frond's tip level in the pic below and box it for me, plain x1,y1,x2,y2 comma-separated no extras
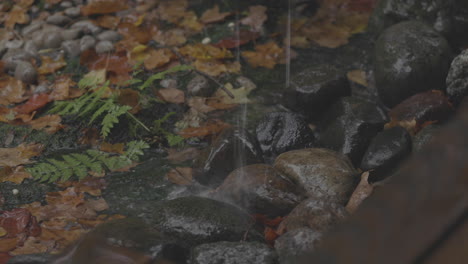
0,144,44,167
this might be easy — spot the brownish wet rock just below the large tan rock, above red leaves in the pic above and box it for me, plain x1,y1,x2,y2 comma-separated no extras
279,198,347,232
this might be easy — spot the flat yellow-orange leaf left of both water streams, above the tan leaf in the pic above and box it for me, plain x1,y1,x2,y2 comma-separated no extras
179,43,233,60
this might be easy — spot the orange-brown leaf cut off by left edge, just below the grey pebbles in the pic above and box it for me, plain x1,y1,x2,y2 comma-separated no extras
0,76,27,105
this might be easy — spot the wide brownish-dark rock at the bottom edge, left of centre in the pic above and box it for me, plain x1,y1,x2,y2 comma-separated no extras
51,218,189,264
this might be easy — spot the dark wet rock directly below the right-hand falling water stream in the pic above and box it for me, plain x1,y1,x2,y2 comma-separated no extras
284,65,351,118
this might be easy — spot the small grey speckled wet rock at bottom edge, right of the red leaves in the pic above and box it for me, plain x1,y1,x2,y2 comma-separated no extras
275,228,322,264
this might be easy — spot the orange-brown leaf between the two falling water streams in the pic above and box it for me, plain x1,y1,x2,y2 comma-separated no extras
242,41,284,69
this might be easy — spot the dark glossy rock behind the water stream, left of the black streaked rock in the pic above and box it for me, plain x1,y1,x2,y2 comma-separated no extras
195,128,263,186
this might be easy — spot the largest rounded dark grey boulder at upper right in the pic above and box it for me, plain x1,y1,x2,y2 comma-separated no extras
374,21,451,107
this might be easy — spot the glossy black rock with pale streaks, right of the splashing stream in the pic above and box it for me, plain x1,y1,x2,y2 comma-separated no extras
256,112,314,160
